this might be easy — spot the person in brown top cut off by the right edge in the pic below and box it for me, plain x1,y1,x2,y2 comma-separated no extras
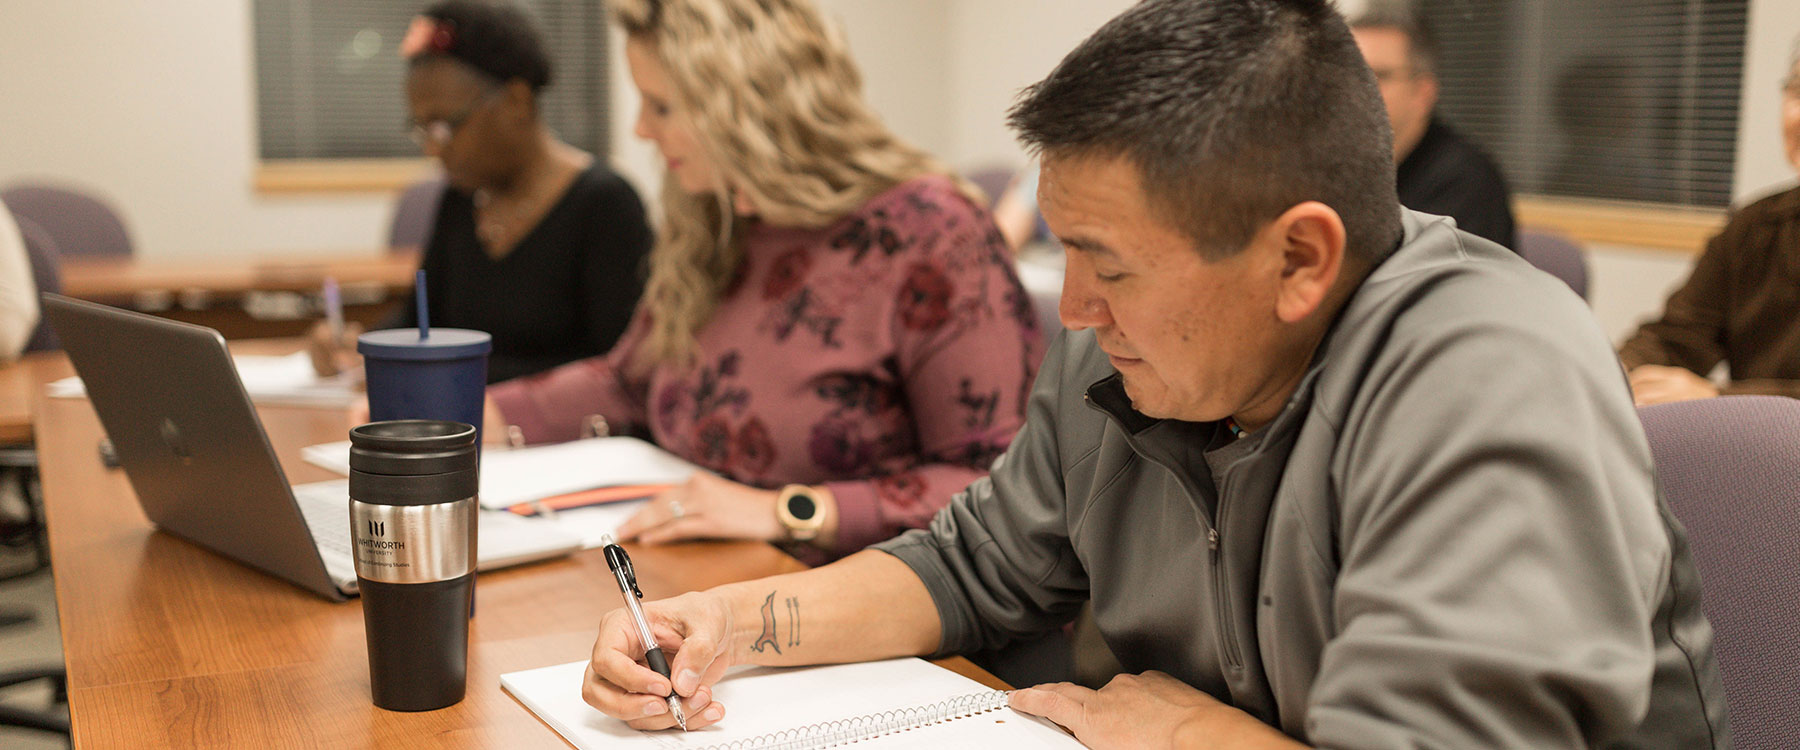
1618,47,1800,406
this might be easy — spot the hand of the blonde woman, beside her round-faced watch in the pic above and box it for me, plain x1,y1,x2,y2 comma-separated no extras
617,471,788,545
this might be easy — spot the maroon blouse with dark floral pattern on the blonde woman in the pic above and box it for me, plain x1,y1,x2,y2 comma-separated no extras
488,176,1042,558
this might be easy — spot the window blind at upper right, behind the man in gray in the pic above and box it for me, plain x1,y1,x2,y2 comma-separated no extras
1420,0,1748,207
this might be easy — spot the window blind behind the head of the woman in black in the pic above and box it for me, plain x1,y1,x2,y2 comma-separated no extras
252,0,608,160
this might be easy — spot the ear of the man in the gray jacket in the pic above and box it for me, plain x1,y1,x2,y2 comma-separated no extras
1264,201,1345,324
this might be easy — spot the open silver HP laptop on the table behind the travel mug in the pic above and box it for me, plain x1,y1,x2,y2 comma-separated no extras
41,293,581,601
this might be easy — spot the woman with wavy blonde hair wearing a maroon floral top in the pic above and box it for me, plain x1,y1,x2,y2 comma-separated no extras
488,0,1040,561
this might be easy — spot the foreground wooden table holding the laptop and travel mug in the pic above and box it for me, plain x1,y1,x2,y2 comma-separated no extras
34,354,1003,748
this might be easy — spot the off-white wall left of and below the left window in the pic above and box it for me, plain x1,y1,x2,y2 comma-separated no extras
0,0,391,257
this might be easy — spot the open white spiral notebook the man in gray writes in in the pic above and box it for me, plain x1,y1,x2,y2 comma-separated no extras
500,658,1082,750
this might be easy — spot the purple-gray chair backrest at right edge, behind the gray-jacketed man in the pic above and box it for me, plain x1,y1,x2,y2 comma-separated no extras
1638,396,1800,750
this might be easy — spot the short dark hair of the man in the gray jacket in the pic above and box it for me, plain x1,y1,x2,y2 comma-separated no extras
1010,0,1400,264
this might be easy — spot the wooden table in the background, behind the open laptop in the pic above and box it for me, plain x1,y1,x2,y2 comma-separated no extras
61,250,419,340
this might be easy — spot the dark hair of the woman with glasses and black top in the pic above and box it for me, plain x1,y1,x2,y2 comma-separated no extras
412,0,551,92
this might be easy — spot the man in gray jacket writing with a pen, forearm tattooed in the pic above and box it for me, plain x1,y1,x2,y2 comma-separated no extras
583,0,1730,748
